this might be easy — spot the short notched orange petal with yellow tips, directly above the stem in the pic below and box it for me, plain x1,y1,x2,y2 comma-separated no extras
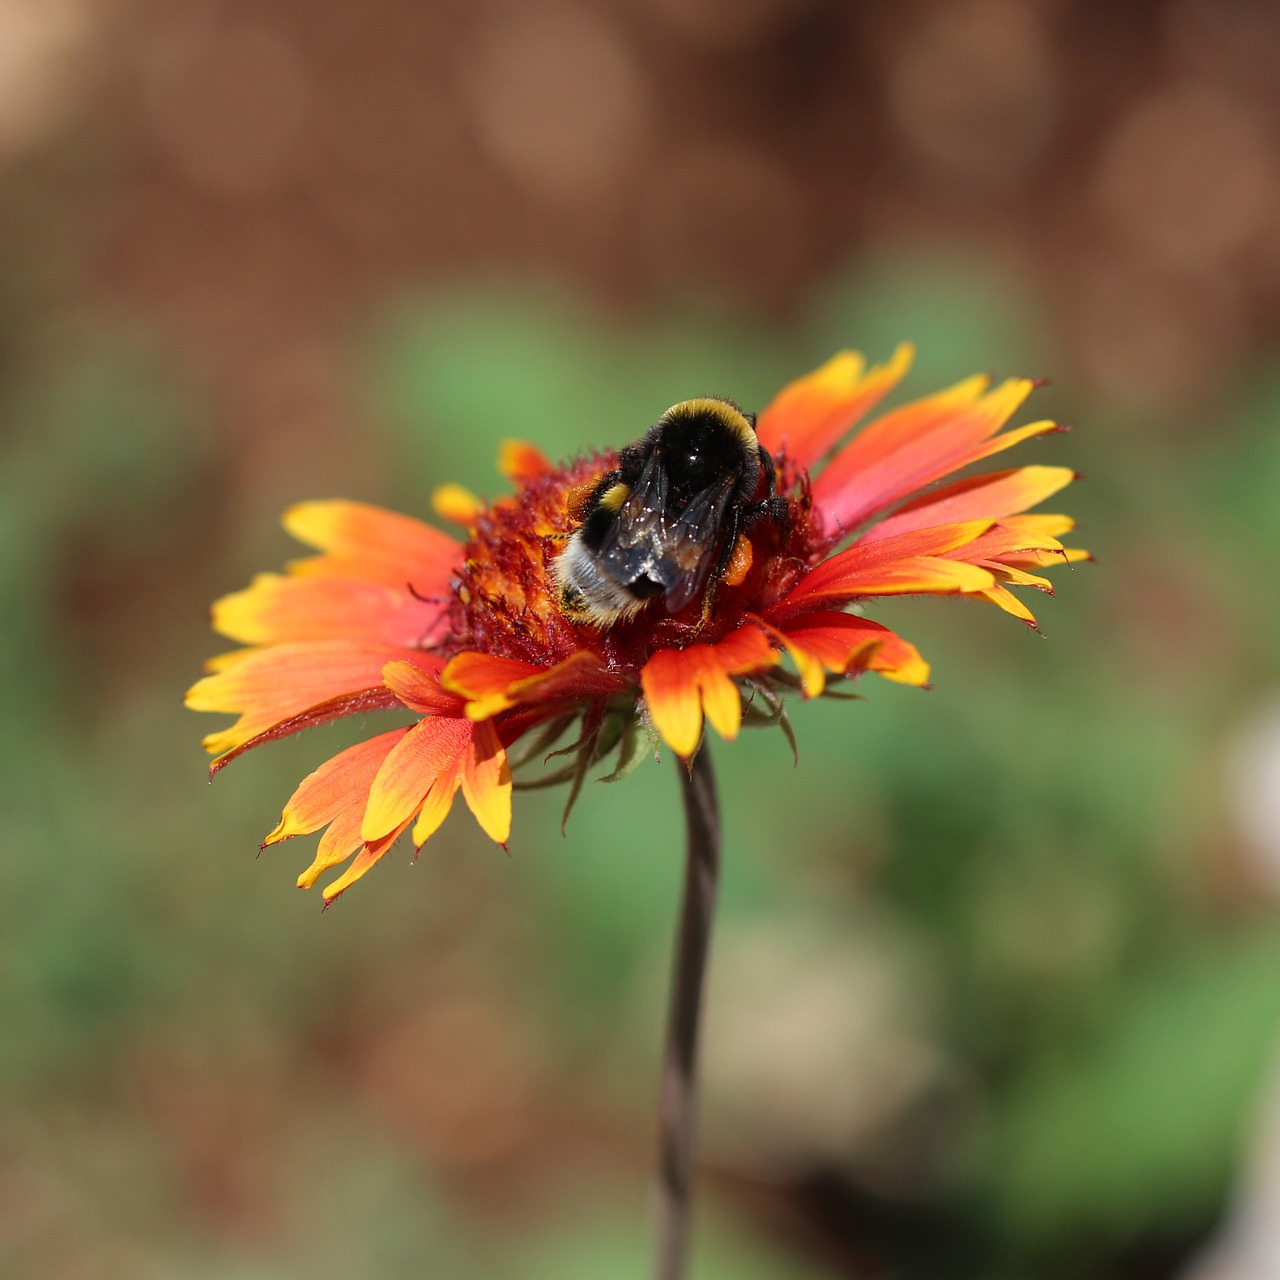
640,626,780,760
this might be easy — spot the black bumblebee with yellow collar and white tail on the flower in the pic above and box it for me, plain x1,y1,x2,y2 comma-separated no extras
553,397,788,630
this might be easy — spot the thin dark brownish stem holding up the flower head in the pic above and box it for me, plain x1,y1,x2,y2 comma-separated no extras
654,742,719,1280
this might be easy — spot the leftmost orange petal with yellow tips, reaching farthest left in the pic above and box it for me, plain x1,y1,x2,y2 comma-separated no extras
186,640,412,758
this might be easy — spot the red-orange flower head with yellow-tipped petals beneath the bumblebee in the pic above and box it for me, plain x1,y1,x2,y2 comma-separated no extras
187,346,1087,902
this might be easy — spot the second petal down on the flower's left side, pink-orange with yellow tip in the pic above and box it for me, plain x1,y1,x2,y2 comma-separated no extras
214,573,443,646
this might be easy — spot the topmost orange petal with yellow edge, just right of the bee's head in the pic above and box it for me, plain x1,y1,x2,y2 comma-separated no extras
755,343,915,468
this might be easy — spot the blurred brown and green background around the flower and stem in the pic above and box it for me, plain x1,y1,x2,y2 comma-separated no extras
0,0,1280,1280
